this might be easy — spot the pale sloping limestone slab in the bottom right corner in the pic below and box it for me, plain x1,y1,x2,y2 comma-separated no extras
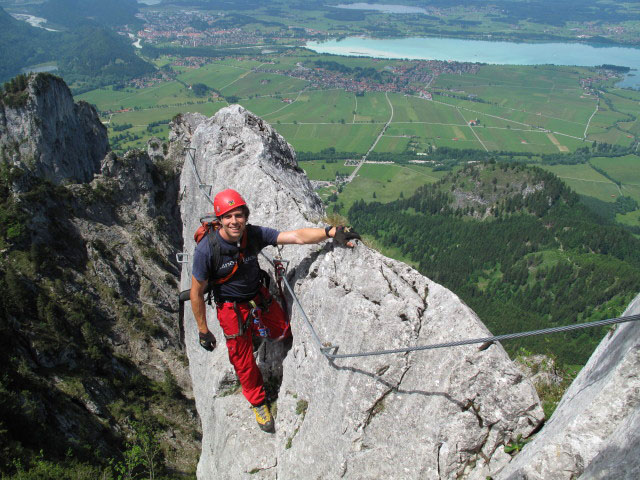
496,296,640,480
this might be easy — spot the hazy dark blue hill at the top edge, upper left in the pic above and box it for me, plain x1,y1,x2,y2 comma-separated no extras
37,0,139,27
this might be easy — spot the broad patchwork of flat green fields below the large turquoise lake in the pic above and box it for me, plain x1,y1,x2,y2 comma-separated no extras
78,50,640,159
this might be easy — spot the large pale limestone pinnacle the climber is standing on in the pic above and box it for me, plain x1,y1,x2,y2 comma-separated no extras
176,106,543,479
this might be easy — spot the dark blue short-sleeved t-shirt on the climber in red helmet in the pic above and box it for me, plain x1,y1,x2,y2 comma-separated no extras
191,225,280,300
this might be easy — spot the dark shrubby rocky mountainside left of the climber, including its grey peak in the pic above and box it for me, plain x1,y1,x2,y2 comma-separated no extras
0,76,200,472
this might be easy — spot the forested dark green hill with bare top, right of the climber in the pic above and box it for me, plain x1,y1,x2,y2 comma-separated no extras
349,163,640,364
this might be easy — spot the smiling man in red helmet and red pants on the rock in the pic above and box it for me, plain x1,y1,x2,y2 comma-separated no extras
190,189,360,432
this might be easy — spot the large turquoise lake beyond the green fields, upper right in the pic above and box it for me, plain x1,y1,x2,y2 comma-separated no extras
306,37,640,88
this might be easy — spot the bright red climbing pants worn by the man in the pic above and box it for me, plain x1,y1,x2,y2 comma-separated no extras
216,288,291,406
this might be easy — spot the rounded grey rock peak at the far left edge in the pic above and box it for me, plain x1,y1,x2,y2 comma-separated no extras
0,74,109,184
